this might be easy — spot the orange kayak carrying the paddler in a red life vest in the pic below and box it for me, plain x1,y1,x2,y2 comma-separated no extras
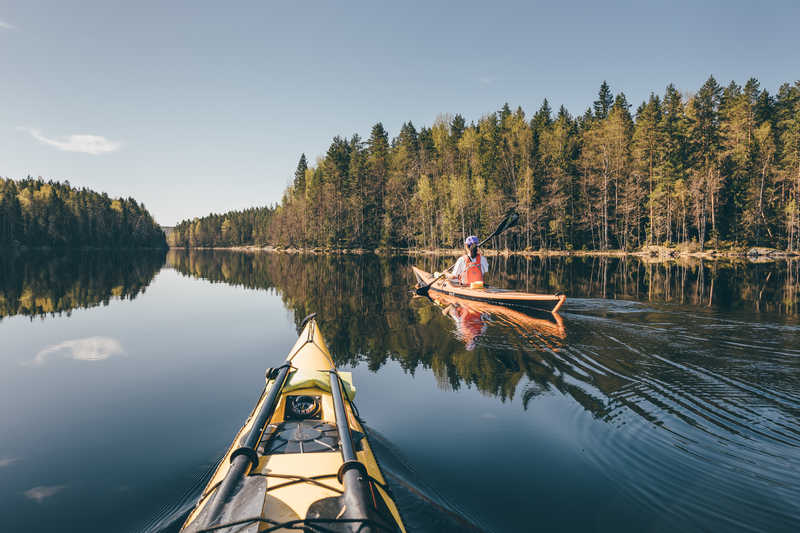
411,266,567,313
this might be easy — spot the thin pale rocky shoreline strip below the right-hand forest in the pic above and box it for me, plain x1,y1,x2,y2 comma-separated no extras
169,245,800,263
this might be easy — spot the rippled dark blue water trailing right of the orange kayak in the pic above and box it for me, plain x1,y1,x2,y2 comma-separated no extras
446,299,800,531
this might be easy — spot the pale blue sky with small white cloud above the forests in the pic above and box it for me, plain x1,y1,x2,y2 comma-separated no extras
0,0,800,225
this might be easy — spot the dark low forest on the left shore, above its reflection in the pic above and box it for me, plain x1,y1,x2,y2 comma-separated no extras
0,177,166,248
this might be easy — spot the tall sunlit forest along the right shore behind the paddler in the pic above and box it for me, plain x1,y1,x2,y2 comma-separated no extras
174,77,800,251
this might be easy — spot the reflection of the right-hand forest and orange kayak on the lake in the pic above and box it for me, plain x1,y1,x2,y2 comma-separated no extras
168,250,798,408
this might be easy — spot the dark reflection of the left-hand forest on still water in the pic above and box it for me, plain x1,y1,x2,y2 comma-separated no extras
0,250,166,320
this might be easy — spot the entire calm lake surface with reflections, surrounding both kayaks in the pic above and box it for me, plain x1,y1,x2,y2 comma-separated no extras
0,252,800,533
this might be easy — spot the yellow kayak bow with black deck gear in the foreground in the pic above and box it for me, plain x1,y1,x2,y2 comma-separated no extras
181,315,406,533
